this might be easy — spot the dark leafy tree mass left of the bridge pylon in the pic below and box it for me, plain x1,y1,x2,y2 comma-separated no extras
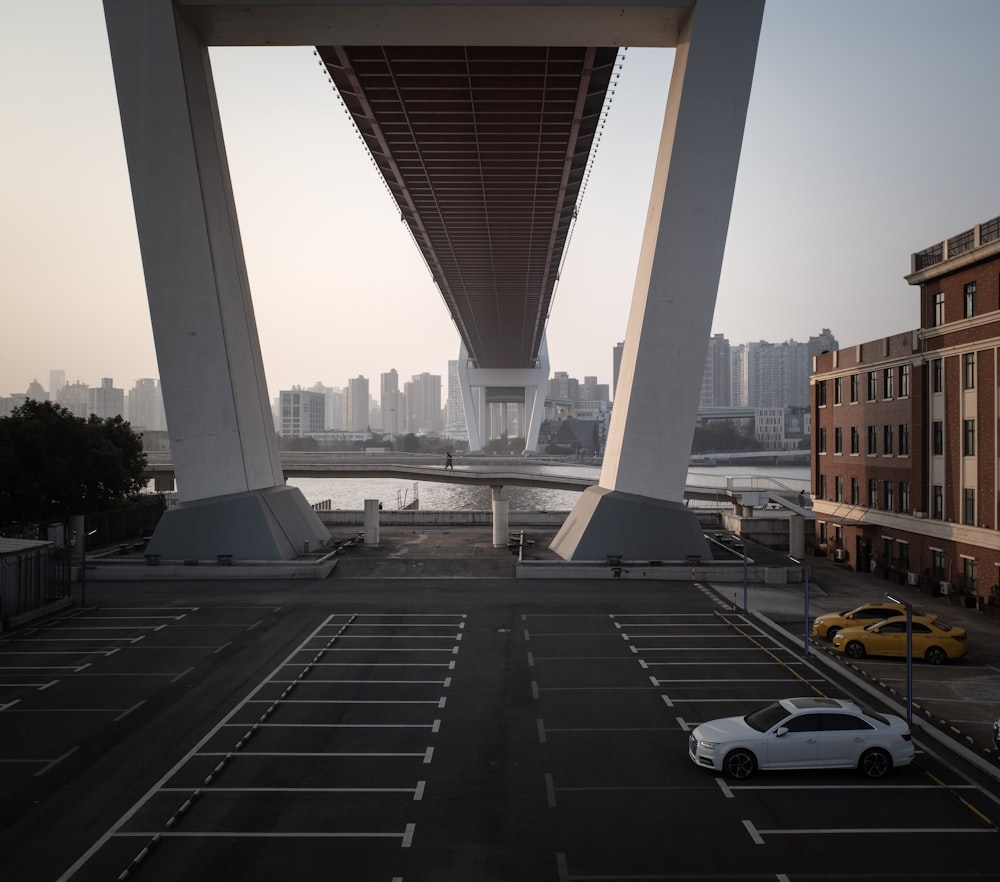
0,399,146,523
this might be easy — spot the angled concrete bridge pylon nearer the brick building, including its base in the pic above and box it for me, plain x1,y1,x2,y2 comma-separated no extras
551,0,764,560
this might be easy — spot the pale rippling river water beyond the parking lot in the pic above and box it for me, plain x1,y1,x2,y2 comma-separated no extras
288,465,809,511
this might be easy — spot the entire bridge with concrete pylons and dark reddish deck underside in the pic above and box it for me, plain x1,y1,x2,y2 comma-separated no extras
104,0,763,559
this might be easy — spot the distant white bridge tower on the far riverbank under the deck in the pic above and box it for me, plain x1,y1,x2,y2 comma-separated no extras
458,336,549,453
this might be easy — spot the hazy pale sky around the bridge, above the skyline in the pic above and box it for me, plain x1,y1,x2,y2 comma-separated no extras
0,0,1000,397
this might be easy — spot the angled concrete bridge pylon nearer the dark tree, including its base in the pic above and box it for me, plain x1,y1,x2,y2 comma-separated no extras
104,0,330,560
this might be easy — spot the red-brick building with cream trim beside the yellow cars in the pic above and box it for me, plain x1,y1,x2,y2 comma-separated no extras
810,217,1000,611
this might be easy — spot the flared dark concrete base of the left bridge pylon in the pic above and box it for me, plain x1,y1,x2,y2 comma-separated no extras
146,486,330,561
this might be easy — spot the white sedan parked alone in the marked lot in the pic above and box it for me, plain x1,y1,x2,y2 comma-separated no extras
688,698,913,778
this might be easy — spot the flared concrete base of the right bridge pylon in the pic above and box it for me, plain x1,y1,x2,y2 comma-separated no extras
549,487,712,561
